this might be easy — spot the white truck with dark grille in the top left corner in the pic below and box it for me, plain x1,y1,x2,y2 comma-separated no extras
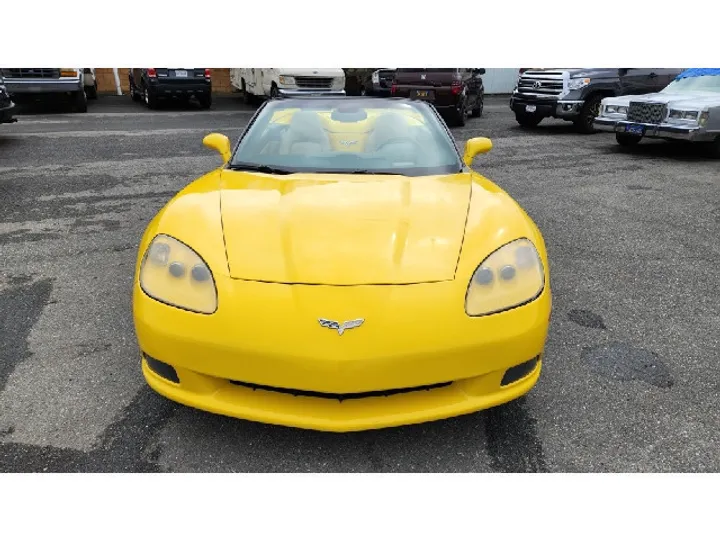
2,68,97,112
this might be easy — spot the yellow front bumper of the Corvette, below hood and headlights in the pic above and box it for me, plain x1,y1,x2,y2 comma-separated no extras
134,282,550,431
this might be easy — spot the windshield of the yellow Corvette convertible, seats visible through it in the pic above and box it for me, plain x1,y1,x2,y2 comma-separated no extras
229,98,463,176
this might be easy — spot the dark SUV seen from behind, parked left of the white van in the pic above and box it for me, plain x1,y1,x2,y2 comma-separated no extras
128,68,212,109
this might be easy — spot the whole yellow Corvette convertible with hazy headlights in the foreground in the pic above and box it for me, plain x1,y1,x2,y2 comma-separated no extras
133,97,551,431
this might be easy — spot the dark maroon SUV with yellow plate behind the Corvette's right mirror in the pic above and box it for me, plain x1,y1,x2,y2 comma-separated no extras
391,68,485,126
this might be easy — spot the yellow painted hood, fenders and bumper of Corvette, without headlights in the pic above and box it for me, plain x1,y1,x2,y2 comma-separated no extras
133,152,551,431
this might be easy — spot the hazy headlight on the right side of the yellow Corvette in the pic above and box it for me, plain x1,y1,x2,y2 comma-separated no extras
465,238,545,317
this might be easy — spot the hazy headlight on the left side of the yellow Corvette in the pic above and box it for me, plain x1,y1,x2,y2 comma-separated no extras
140,234,218,315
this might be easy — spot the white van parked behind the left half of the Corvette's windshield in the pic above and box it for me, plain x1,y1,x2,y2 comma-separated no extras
230,68,345,103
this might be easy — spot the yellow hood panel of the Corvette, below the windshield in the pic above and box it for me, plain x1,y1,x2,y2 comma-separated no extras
220,170,471,285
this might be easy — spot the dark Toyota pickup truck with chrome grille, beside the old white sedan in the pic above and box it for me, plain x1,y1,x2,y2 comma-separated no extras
510,68,683,133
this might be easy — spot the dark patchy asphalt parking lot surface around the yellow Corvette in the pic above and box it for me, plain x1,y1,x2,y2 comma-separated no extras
0,96,720,472
